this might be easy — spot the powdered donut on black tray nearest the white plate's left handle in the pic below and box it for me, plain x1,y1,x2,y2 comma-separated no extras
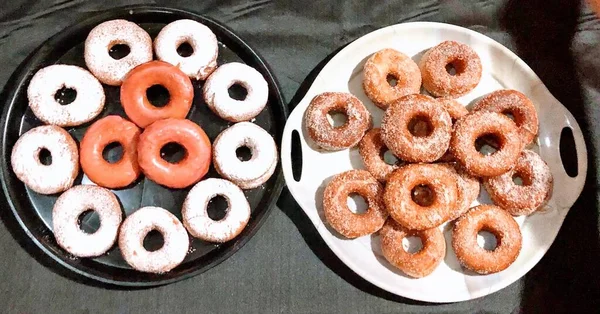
213,122,278,190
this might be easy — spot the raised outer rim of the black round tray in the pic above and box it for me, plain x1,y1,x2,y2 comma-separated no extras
0,4,289,288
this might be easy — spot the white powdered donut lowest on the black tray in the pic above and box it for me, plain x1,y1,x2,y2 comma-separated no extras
119,206,190,273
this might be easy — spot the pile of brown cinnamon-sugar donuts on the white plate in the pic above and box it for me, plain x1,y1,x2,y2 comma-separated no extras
304,41,553,278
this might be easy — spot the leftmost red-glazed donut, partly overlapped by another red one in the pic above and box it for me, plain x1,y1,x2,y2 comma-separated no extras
79,115,140,189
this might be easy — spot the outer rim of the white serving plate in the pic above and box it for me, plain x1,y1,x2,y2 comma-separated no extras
281,22,588,303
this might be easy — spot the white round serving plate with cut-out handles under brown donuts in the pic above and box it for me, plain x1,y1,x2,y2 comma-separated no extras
281,22,587,302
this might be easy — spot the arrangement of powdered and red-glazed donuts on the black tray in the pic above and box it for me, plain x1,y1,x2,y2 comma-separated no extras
11,20,278,273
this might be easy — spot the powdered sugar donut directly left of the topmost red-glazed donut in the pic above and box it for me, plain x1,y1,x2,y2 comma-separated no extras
27,64,105,127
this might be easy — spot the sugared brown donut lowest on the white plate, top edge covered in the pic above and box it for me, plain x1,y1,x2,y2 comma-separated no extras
379,219,446,278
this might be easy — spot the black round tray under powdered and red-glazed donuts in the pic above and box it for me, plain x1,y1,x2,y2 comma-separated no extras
0,6,288,286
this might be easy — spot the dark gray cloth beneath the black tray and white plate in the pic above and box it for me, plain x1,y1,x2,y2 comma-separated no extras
0,0,600,313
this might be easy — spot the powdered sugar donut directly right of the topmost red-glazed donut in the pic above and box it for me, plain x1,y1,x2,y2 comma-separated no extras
204,62,269,122
